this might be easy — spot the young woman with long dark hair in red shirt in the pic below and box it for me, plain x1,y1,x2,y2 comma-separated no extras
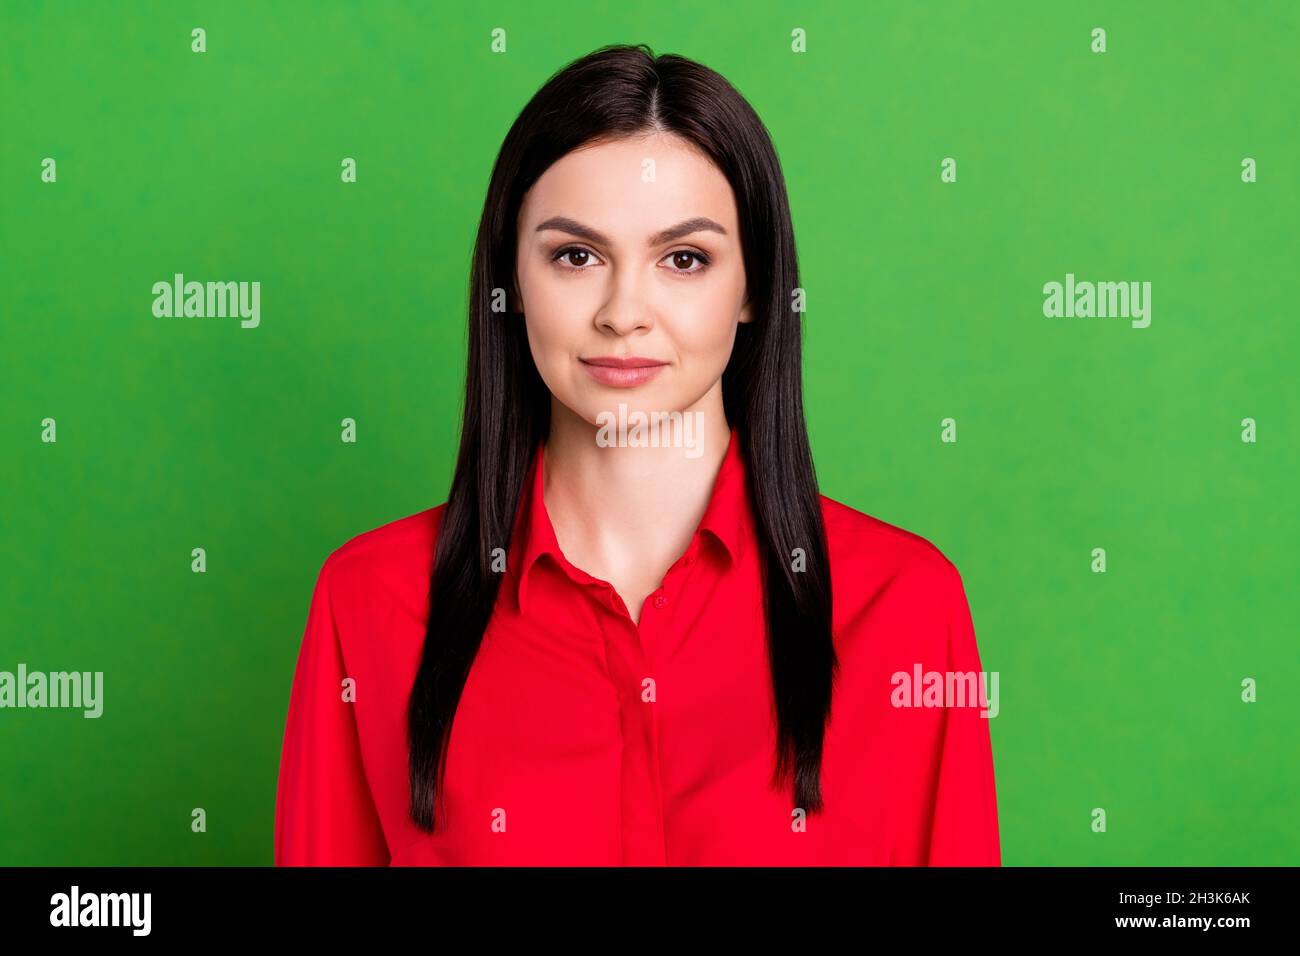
276,46,1000,866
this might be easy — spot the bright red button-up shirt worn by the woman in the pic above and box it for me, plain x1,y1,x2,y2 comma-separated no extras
274,433,1001,866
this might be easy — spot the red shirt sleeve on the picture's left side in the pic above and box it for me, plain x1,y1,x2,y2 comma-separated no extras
274,561,389,866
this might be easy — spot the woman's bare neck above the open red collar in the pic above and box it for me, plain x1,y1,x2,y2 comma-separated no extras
543,382,731,622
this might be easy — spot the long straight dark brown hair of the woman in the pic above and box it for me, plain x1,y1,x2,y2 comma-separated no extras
407,44,837,832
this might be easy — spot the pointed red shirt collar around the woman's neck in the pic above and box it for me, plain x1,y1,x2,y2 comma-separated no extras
507,428,754,611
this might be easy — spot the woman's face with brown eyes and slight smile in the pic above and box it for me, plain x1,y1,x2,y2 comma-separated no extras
515,133,751,425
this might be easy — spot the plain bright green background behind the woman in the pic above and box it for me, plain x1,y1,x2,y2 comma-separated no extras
0,0,1300,865
